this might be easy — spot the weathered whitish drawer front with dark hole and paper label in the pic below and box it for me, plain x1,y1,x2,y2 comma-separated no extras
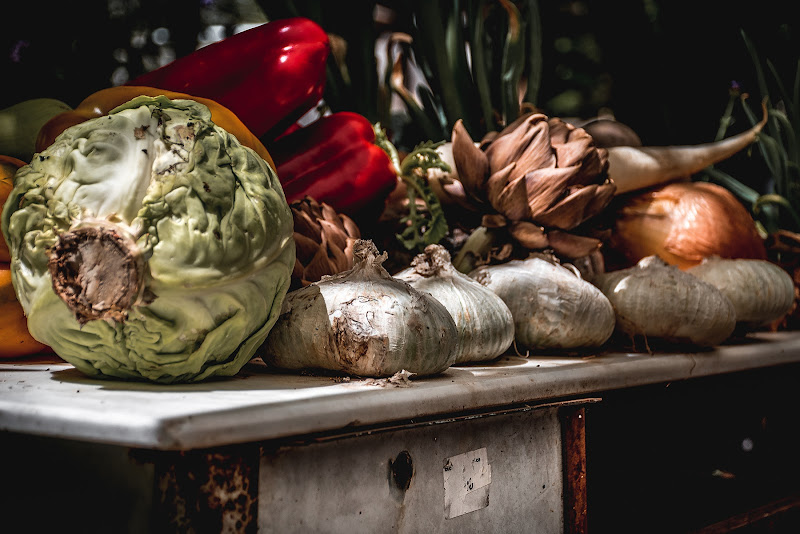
258,407,563,534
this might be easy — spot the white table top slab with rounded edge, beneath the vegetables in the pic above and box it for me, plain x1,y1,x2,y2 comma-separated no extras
0,332,800,450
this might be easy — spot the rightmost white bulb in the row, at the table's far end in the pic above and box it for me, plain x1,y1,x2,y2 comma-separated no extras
686,256,795,328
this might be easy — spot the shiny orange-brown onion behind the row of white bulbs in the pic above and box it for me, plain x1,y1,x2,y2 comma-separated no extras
604,182,767,269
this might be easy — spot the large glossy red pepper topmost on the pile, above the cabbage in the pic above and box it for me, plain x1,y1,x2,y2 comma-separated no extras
126,17,330,140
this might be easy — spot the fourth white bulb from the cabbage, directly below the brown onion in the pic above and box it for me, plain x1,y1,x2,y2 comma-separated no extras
593,256,736,346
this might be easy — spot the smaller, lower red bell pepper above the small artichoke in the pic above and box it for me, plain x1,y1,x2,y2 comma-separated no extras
267,111,398,220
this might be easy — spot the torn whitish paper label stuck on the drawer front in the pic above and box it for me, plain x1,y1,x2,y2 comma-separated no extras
444,448,492,519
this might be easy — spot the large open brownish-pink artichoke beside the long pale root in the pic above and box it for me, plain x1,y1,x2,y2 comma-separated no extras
452,112,615,259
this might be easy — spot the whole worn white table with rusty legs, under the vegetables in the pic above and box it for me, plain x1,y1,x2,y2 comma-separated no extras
0,333,800,532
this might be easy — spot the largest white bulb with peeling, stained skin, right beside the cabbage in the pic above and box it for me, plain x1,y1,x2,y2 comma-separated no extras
259,239,458,378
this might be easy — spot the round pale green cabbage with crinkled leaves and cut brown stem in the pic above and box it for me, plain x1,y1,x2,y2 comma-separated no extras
2,97,295,383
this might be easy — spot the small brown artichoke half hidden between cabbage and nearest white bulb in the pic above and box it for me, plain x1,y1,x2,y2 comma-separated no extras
290,196,361,290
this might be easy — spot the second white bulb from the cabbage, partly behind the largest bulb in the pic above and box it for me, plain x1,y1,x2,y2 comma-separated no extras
395,245,514,364
